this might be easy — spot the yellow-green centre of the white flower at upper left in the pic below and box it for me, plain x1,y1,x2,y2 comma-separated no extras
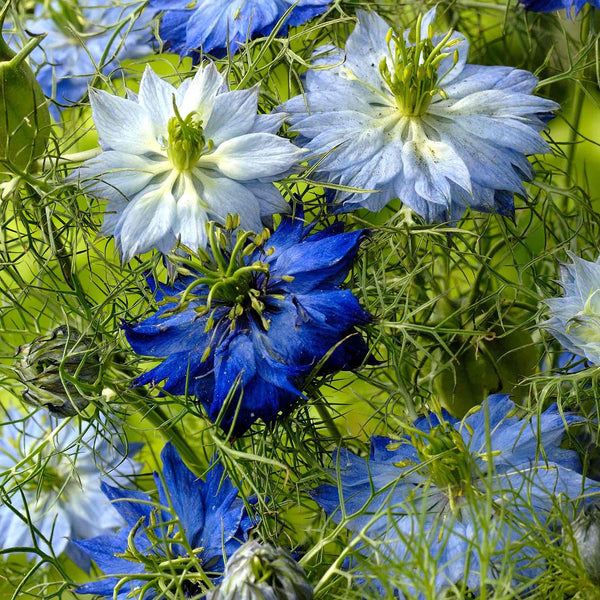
167,101,212,171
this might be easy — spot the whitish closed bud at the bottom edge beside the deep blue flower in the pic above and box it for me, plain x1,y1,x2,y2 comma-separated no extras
211,541,313,600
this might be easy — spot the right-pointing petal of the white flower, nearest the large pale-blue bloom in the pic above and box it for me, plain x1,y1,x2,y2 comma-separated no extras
198,133,305,181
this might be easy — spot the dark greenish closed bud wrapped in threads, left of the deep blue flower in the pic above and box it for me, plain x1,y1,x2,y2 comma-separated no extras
16,326,101,417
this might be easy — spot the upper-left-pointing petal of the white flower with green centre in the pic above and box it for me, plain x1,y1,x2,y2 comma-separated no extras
90,89,160,154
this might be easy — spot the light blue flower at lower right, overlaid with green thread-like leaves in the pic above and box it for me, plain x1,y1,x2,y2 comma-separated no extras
314,394,600,597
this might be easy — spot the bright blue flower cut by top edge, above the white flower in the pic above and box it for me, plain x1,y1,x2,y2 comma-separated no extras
150,0,330,58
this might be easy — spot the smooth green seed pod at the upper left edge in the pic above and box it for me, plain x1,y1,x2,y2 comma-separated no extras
0,2,50,171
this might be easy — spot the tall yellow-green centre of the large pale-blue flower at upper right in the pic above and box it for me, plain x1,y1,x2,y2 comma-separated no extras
379,15,458,117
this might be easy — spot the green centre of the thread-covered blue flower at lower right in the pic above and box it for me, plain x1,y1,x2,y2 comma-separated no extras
416,425,472,496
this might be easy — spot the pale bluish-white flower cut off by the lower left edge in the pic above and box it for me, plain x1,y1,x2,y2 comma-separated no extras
0,409,141,569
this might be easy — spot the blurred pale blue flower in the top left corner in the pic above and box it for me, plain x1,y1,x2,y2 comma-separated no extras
18,0,155,119
